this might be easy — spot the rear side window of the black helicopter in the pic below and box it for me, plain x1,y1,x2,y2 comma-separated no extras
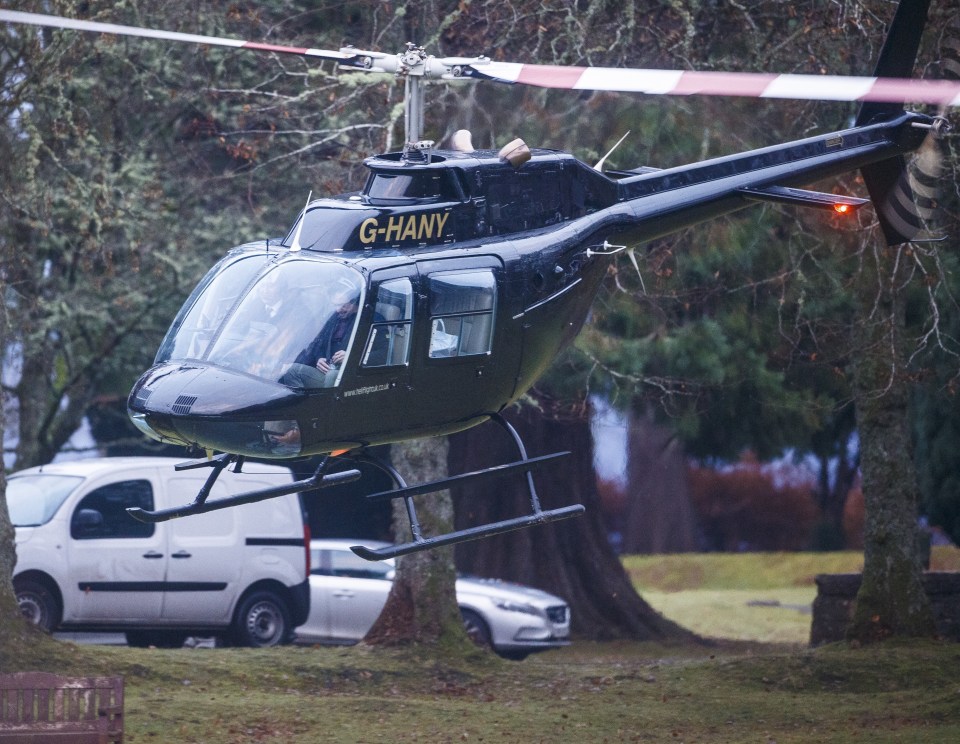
430,269,497,359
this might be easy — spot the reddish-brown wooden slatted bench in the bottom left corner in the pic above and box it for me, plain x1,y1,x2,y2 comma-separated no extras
0,672,123,744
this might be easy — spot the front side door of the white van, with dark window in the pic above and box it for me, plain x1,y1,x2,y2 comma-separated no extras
63,473,167,624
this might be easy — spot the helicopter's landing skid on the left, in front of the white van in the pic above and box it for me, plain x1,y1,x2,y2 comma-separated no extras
127,454,360,523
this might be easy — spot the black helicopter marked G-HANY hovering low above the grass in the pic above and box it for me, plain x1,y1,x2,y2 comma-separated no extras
0,0,960,560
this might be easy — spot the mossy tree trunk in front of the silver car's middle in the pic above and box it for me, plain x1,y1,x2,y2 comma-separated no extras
364,438,470,650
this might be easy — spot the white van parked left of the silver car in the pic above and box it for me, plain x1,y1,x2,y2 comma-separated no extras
7,457,310,647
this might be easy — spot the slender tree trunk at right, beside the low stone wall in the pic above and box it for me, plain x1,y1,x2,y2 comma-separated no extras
847,242,936,643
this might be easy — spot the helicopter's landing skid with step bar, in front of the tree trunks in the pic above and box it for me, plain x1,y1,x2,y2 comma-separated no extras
350,414,585,561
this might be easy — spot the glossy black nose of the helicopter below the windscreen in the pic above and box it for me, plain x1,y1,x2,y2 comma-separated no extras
127,363,300,457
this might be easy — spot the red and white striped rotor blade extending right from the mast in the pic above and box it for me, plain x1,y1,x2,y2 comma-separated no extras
461,60,960,106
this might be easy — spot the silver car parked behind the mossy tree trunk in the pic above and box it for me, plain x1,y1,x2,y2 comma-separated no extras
296,540,570,659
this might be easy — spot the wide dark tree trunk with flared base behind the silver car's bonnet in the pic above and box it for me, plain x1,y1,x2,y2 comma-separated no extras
450,392,694,640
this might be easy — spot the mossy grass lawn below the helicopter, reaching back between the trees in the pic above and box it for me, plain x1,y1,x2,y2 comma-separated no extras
7,544,960,744
